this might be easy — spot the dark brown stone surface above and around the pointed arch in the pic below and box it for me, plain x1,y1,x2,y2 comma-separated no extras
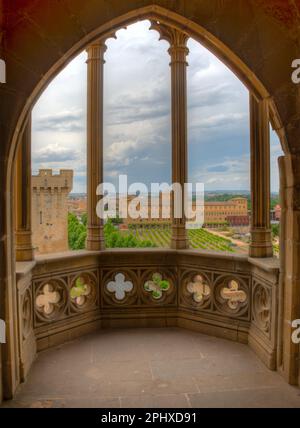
0,0,300,159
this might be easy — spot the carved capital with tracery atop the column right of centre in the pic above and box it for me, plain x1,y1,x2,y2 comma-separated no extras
150,20,189,62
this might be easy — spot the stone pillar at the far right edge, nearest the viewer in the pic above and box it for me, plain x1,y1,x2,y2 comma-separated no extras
279,154,300,385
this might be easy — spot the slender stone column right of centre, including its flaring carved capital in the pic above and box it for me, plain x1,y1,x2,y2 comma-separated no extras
151,21,189,249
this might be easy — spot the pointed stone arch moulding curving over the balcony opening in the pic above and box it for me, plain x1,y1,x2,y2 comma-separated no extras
5,5,289,166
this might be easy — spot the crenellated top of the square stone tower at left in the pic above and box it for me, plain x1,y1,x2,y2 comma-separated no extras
31,169,73,193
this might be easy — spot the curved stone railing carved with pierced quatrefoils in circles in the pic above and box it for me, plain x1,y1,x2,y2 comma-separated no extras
17,249,279,377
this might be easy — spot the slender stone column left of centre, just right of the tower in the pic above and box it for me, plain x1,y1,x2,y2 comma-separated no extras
86,40,106,251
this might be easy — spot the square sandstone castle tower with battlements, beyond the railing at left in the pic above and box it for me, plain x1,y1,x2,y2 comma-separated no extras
31,169,73,254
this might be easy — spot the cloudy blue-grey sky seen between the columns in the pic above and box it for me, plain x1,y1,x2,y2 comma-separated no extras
32,21,282,193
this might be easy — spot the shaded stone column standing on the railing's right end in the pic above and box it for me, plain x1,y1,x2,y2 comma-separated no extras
249,95,273,257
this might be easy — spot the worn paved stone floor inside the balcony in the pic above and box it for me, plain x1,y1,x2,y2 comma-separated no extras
4,328,300,408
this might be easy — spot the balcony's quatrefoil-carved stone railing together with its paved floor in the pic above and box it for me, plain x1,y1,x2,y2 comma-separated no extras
1,249,292,407
